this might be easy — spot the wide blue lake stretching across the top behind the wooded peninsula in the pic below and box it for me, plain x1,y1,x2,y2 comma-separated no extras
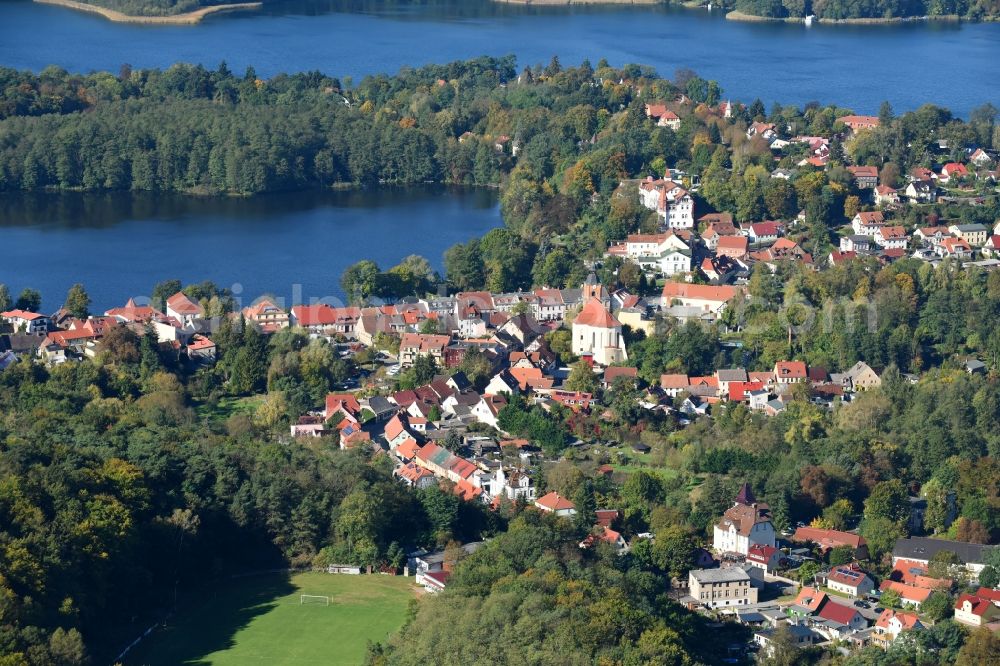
0,0,1000,115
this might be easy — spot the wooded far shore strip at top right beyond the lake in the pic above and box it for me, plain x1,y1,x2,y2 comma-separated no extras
734,0,1000,21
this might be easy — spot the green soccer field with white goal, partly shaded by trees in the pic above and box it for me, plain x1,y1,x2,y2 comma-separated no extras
125,572,414,666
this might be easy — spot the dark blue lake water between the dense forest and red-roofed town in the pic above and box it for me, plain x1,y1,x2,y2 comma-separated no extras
0,187,501,311
